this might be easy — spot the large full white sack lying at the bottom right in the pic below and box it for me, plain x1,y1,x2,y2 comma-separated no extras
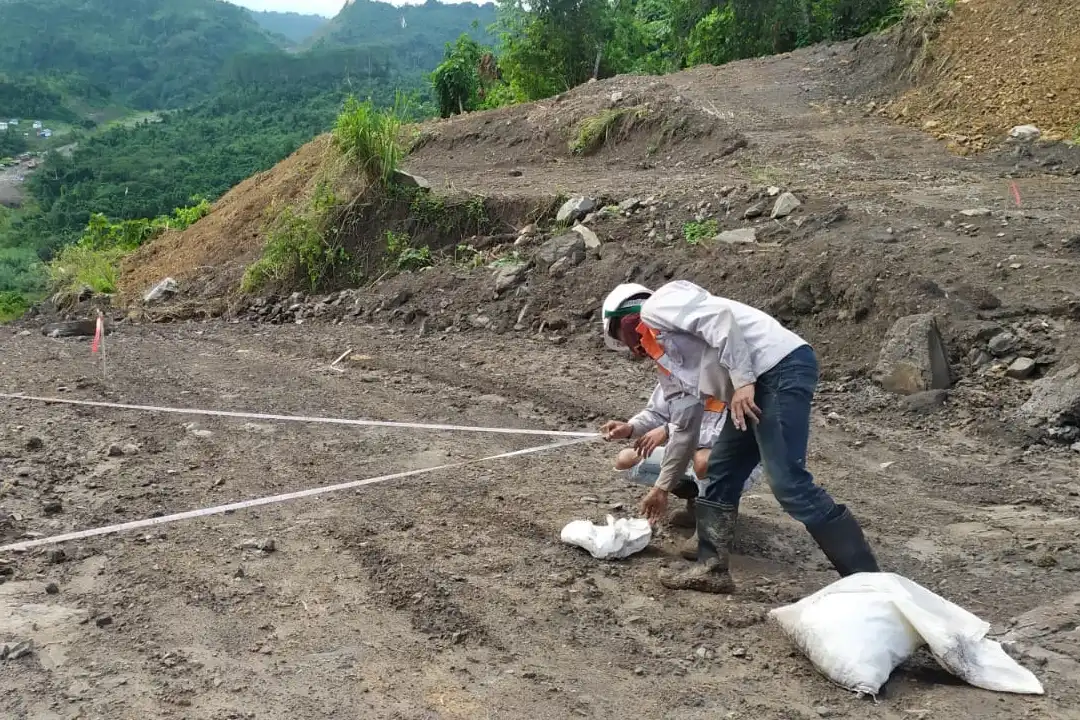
769,572,1043,695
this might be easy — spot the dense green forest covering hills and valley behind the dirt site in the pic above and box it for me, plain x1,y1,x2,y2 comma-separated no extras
0,0,907,313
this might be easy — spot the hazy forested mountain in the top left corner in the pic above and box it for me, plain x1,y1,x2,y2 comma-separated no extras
0,0,278,112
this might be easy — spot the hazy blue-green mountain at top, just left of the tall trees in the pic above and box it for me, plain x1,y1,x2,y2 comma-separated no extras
308,0,495,71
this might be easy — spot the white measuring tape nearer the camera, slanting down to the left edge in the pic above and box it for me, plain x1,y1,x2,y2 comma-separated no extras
0,437,596,553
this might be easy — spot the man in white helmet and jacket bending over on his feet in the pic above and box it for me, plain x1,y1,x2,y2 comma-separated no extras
604,281,878,593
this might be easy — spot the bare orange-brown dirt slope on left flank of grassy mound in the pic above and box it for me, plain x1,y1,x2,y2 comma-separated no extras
120,135,330,298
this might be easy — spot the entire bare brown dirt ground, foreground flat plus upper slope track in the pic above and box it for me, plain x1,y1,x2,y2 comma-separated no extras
6,14,1080,720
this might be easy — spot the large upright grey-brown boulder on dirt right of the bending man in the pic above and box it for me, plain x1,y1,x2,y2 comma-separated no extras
874,313,953,395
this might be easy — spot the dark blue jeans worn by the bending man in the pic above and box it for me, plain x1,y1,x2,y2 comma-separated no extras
704,345,840,528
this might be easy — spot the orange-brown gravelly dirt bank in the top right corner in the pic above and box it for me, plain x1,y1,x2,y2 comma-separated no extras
888,0,1080,151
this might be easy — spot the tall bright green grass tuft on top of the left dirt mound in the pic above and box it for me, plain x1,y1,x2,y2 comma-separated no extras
334,98,404,186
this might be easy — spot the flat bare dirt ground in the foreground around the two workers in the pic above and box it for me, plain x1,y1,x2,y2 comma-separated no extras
6,324,1080,719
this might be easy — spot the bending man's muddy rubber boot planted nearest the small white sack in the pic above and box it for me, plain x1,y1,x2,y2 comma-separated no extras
660,499,739,595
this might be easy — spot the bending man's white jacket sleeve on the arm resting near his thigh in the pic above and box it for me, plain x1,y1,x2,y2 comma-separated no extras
642,283,757,390
